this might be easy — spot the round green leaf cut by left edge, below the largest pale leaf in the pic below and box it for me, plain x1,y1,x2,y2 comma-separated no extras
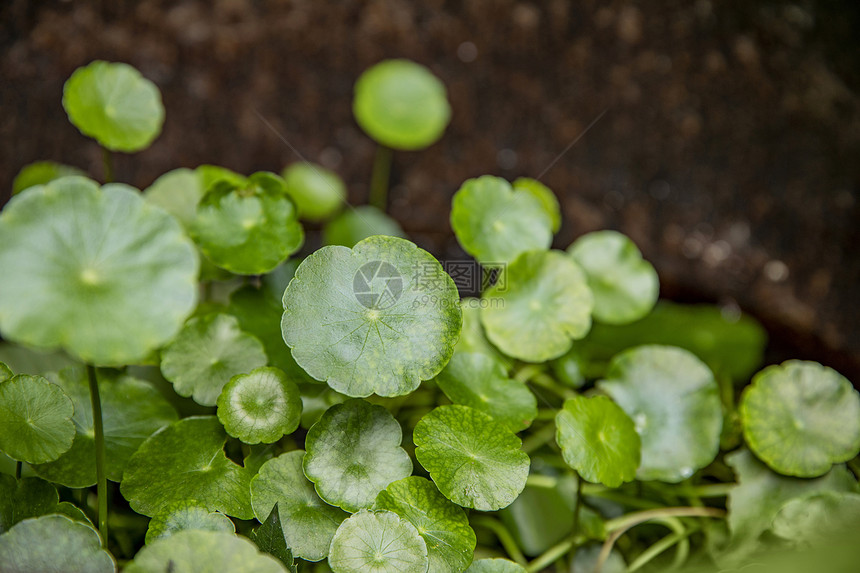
0,374,75,464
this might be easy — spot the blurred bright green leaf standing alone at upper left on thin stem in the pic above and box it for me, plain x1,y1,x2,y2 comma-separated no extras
63,60,164,153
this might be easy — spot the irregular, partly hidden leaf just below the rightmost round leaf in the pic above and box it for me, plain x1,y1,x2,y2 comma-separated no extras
722,450,858,562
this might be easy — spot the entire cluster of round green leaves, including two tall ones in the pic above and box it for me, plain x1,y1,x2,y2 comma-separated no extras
0,60,860,573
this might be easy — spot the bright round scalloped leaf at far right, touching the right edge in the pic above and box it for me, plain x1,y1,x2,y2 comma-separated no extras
740,360,860,478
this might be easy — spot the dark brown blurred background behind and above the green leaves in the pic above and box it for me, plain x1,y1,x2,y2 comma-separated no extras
0,0,860,384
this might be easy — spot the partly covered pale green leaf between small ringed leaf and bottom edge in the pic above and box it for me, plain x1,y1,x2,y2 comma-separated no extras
251,450,347,561
